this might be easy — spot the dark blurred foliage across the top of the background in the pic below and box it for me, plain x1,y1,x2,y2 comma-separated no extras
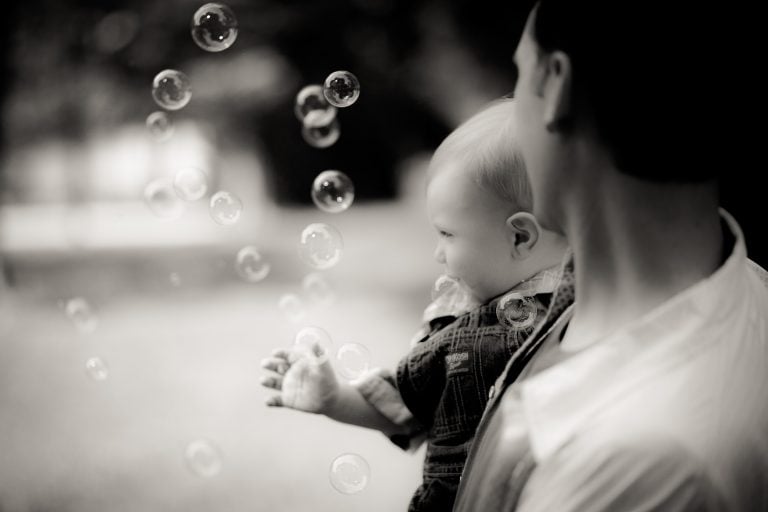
2,0,527,203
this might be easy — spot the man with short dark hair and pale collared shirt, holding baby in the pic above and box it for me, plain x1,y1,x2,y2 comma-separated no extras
454,0,768,512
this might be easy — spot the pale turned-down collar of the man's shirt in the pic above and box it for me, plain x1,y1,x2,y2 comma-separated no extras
513,210,747,460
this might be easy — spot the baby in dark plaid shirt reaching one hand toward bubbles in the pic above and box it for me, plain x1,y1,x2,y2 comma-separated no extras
262,99,567,511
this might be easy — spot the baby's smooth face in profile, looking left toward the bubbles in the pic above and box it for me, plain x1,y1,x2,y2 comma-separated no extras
427,166,520,302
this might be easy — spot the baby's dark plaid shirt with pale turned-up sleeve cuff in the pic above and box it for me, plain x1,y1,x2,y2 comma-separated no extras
357,269,559,511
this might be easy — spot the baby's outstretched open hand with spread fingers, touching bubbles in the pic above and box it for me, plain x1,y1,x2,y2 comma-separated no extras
261,344,339,414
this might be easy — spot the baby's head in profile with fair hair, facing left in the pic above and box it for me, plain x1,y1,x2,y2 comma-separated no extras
427,99,566,302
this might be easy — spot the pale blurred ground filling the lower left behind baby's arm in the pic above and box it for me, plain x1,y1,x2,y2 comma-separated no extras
0,194,439,512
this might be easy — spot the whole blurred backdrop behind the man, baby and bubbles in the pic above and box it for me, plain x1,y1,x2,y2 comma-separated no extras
0,0,766,512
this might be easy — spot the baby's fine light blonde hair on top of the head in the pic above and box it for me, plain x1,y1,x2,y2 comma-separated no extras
427,98,533,212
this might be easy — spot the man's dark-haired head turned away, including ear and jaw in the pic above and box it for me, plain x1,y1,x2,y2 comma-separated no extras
515,0,722,228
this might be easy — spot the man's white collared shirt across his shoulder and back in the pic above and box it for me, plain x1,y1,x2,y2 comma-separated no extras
510,212,768,512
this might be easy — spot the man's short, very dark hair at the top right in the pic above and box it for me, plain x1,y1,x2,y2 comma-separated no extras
532,0,729,183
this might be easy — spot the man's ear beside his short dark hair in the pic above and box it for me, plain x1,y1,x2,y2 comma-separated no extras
537,50,572,132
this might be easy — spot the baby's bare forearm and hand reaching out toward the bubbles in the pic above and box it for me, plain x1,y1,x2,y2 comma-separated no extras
261,345,404,436
